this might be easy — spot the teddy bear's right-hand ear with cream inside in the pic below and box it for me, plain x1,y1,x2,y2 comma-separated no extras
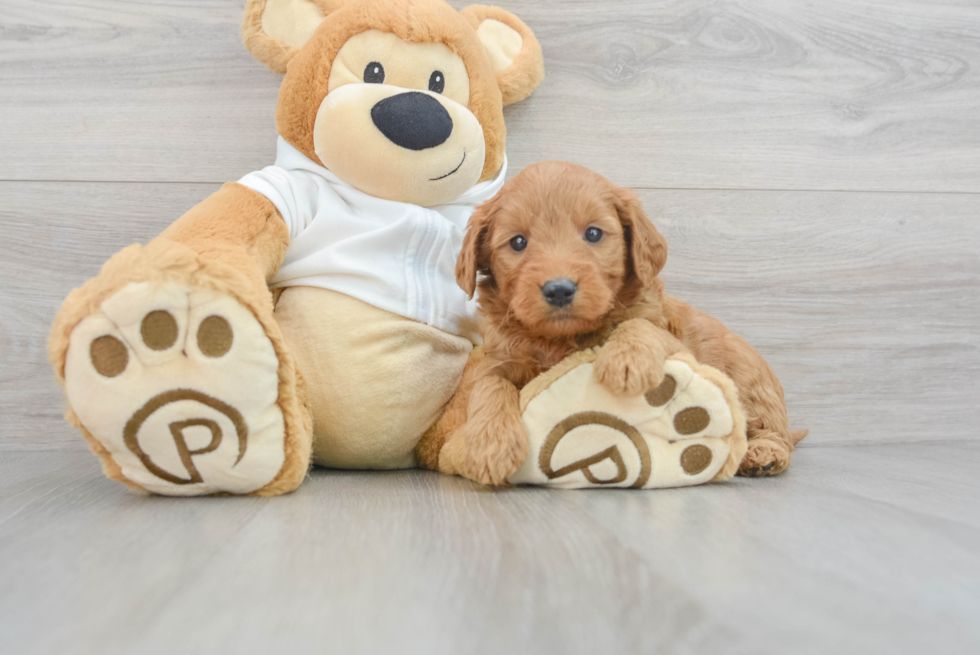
460,5,544,105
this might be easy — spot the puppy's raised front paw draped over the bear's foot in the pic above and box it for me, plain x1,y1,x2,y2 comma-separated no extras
594,318,686,396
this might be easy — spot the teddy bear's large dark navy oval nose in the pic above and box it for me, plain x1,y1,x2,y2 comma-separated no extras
371,91,453,150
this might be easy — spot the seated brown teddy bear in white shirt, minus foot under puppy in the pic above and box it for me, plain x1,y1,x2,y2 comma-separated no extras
49,0,544,495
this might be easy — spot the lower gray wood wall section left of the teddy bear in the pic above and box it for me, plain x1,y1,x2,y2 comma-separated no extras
0,182,218,449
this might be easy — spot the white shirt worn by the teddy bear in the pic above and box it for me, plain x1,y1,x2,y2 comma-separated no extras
239,137,507,339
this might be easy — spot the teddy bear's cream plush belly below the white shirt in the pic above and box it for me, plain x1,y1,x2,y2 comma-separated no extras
276,287,472,469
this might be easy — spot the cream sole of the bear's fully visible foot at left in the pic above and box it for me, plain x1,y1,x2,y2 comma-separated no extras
65,283,285,496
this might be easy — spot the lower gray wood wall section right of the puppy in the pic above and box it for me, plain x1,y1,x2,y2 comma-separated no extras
652,191,980,444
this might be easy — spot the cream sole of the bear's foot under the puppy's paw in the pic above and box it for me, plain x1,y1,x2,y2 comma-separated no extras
509,350,746,489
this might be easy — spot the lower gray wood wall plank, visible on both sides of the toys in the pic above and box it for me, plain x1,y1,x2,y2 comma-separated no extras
0,183,980,449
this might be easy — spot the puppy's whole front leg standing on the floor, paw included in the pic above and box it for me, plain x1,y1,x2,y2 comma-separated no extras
458,375,528,485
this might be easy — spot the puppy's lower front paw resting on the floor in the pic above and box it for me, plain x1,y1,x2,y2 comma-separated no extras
461,415,528,486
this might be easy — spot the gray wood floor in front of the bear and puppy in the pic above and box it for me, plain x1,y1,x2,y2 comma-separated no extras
0,443,980,654
